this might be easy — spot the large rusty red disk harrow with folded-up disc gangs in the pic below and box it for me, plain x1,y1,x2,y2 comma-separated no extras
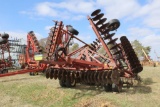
0,9,143,92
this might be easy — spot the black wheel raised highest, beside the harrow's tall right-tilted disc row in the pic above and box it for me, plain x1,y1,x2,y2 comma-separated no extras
108,19,120,31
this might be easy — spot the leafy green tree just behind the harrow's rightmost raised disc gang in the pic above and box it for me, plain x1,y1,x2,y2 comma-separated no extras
131,40,151,59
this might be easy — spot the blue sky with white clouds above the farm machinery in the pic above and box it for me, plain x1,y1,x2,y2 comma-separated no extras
0,0,160,60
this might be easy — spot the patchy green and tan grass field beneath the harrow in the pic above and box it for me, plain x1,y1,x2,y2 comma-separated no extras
0,67,160,107
